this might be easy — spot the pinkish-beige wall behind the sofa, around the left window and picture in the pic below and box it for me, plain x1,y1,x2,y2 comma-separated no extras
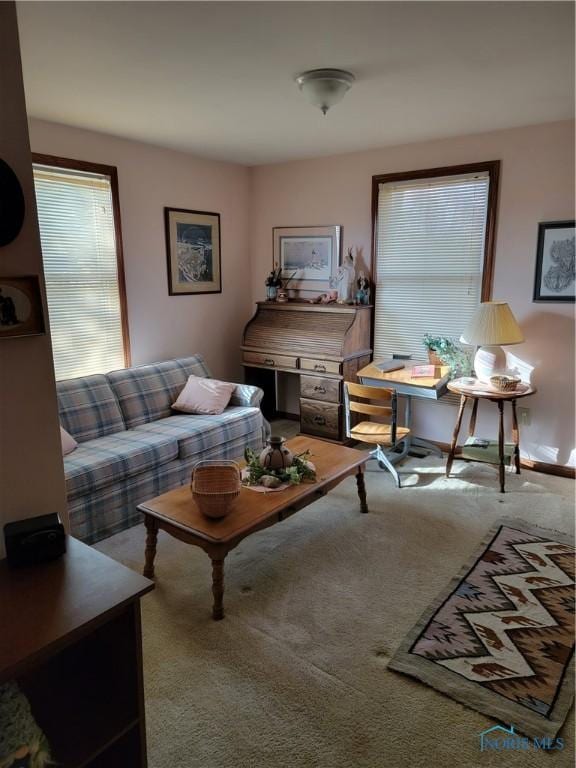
30,120,251,380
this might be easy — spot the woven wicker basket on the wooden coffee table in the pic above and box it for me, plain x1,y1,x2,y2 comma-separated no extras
190,461,242,518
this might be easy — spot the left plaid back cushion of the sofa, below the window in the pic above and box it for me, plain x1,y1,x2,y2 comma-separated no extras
56,374,126,443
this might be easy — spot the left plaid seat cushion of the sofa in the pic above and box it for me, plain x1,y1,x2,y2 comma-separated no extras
64,430,178,498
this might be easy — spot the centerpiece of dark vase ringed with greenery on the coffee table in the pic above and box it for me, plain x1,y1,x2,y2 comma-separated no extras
242,436,316,490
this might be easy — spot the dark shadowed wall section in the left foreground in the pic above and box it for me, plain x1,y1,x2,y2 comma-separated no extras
0,2,65,558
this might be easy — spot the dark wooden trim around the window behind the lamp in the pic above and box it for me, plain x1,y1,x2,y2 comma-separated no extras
371,160,500,303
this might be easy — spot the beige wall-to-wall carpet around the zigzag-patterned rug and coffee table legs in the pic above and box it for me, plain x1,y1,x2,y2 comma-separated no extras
97,457,574,768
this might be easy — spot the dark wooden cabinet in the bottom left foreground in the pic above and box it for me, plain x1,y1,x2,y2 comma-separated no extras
0,538,154,768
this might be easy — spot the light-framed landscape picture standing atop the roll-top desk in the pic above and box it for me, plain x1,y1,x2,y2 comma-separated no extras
272,226,342,293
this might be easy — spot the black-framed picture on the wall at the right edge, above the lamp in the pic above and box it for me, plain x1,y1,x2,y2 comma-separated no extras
534,221,575,302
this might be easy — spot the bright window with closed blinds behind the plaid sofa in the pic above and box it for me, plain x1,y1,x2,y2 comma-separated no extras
33,154,130,379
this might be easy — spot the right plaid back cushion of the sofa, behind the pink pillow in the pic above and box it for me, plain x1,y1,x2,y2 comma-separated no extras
106,355,208,429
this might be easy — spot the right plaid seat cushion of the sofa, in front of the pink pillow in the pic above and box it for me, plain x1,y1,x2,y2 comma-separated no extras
134,406,262,459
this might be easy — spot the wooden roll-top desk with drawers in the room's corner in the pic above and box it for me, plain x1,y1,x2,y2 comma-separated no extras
242,301,372,442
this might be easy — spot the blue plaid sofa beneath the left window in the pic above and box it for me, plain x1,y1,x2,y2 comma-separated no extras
57,355,269,544
